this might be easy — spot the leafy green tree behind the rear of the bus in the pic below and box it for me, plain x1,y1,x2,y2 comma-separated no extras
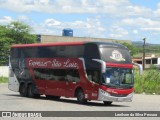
0,22,36,65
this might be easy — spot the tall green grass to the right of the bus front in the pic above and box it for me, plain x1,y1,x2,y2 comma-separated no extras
134,69,160,95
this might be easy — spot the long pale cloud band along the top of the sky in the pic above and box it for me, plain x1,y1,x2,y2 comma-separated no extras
0,0,152,17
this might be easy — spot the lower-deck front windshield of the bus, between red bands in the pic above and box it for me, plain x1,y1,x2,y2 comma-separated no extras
102,67,134,88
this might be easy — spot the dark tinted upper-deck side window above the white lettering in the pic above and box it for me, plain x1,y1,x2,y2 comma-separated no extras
16,45,84,58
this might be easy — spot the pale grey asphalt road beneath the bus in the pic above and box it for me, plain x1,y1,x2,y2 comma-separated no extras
0,84,160,120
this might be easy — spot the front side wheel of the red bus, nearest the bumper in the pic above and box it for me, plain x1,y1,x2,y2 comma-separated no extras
77,89,87,104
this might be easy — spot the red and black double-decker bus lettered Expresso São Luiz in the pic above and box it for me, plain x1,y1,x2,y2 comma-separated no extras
8,42,141,105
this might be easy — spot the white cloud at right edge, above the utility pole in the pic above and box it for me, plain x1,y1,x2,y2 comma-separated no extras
117,17,160,37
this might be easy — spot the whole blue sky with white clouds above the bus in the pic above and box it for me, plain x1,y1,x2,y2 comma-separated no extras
0,0,160,44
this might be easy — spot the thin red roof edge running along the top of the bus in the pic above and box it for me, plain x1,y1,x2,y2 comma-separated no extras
11,41,126,48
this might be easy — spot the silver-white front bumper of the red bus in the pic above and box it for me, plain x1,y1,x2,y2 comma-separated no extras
98,89,133,102
